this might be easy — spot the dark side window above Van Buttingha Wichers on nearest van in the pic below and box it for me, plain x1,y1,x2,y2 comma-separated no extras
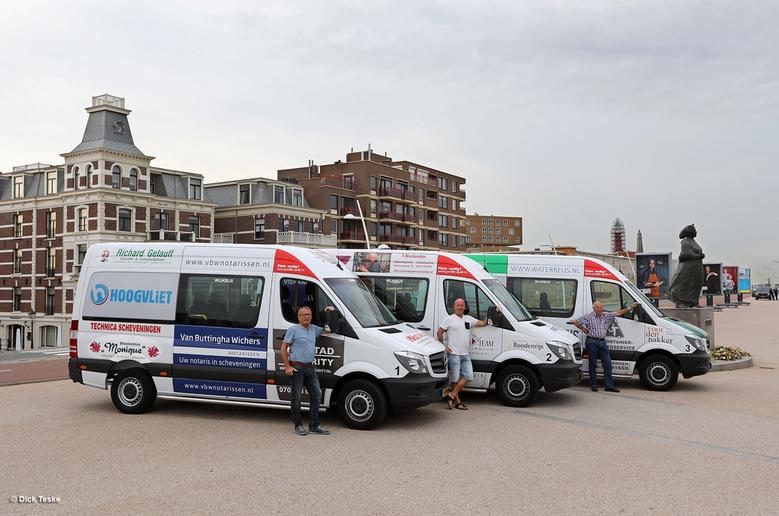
176,274,265,328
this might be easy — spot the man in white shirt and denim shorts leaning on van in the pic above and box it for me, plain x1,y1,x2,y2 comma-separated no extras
437,299,487,410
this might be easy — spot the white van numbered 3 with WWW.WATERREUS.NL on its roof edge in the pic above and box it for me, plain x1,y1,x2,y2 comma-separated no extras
468,254,711,391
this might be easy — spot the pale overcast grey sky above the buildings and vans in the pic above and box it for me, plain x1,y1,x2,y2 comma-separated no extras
0,0,779,282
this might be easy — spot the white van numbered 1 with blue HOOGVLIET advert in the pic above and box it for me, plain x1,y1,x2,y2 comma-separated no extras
68,243,447,429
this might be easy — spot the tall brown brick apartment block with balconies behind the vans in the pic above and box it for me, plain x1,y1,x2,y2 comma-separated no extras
277,149,466,252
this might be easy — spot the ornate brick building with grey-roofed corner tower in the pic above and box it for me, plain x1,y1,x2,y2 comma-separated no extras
0,95,214,349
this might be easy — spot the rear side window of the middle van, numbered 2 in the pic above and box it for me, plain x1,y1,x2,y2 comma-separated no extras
360,276,428,322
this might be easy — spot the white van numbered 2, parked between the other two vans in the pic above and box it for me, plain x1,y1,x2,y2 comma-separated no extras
327,249,581,407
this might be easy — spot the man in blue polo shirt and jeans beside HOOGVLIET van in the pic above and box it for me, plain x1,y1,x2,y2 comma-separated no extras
281,306,334,435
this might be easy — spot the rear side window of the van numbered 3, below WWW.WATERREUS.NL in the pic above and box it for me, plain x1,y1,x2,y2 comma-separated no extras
506,278,578,318
